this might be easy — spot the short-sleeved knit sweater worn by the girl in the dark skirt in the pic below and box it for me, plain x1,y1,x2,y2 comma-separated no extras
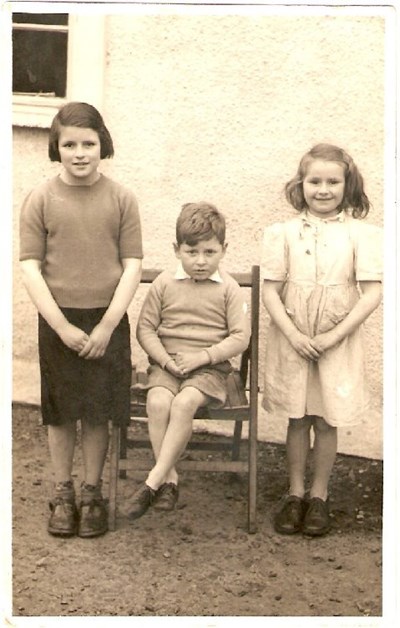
19,175,143,309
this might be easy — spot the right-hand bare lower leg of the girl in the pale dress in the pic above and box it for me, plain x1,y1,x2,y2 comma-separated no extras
310,417,337,501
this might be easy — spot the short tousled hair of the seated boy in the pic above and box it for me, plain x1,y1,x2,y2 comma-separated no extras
176,202,225,246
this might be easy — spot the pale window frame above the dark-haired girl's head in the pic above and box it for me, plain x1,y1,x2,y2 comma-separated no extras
12,13,105,128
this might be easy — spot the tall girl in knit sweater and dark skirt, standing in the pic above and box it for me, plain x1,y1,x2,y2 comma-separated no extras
20,103,143,537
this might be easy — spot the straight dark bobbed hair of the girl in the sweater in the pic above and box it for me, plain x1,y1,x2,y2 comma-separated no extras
49,102,114,161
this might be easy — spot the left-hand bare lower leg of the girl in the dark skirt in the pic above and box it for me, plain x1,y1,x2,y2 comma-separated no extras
47,421,76,483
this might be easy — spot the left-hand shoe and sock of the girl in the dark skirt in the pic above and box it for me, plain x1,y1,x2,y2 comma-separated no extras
47,482,78,536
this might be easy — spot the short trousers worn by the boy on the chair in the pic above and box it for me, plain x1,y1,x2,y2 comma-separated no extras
145,361,232,408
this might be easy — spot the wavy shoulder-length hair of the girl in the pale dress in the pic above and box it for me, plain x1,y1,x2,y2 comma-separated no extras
285,144,370,218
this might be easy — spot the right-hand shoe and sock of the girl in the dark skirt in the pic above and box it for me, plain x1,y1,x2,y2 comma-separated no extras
78,482,108,538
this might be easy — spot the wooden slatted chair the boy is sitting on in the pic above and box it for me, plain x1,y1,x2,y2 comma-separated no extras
109,266,260,533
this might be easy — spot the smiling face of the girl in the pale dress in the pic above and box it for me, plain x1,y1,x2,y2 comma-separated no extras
303,159,346,218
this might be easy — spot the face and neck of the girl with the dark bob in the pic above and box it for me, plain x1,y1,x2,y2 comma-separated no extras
58,126,101,185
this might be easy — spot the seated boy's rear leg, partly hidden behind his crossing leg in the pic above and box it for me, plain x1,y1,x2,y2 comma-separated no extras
147,386,178,484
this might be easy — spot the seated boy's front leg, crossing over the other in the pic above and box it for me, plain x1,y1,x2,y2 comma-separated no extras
146,386,209,490
